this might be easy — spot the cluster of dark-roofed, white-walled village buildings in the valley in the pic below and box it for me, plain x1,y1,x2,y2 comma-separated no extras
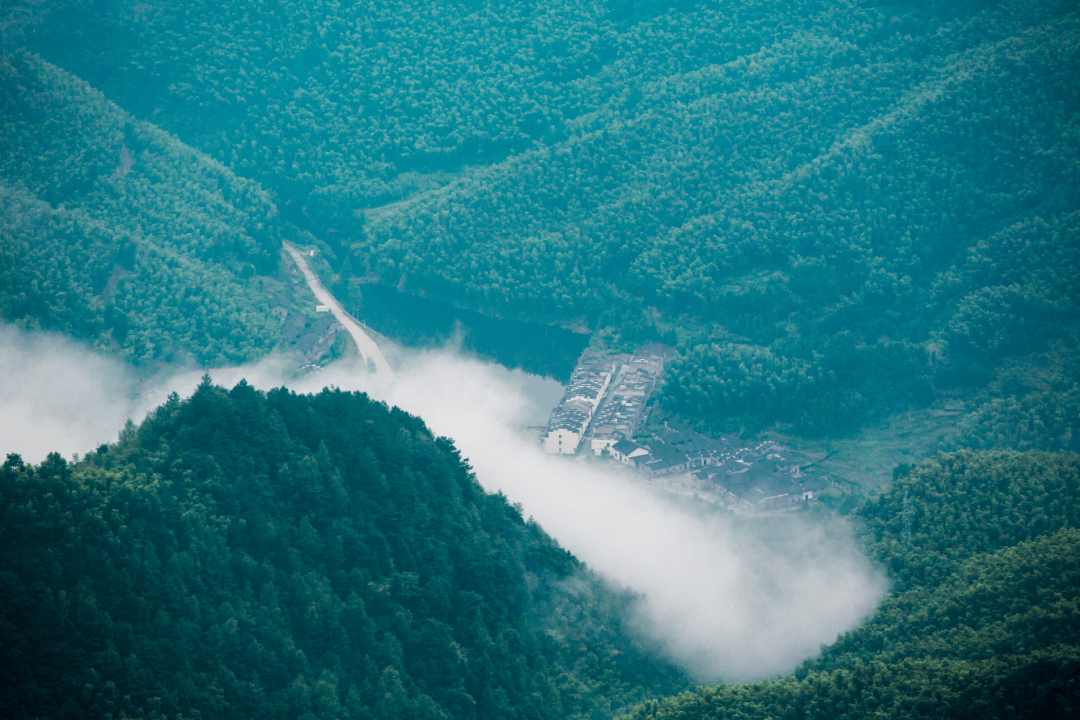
542,344,826,513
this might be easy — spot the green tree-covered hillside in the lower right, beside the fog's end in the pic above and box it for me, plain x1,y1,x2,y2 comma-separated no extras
617,451,1080,720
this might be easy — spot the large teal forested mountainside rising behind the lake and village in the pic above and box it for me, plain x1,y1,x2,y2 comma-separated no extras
16,0,1080,440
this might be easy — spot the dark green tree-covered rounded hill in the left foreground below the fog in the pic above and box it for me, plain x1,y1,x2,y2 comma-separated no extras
0,381,686,720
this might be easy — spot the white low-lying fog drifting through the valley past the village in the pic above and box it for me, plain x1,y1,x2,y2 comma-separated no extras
0,327,886,681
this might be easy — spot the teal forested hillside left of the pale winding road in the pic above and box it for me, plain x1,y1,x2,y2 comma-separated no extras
0,53,291,364
